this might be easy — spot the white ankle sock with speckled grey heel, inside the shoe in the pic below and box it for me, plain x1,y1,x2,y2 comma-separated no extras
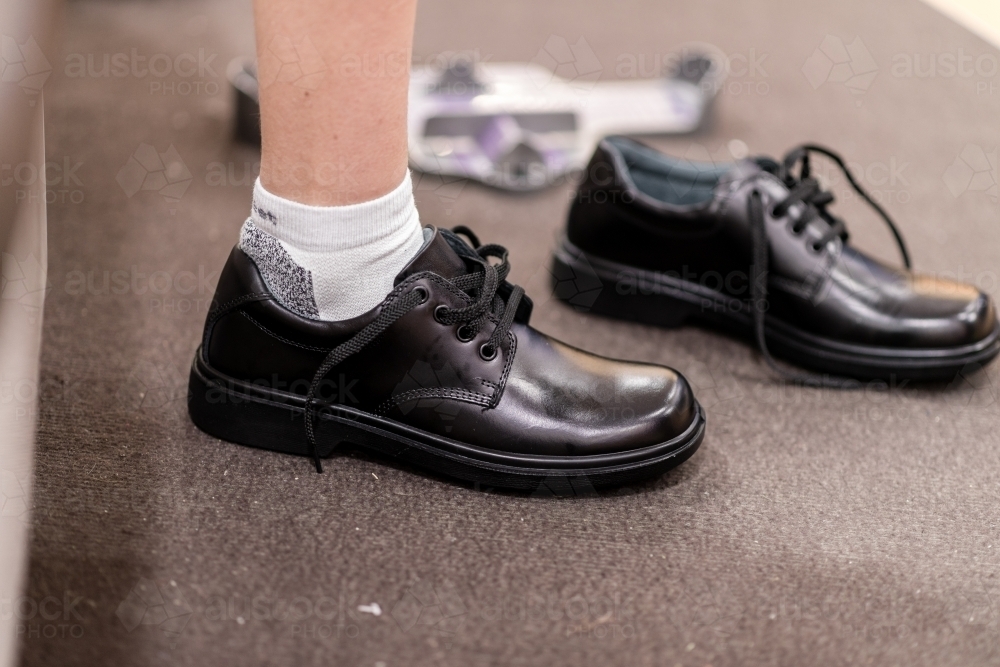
246,172,424,320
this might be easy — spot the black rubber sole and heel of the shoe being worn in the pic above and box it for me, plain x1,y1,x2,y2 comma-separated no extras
188,348,705,495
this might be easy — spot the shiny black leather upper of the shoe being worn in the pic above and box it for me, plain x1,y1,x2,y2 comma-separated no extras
202,231,698,456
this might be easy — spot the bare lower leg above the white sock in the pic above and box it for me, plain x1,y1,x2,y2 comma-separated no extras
254,0,417,206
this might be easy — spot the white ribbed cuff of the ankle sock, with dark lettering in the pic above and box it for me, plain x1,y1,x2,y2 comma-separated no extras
250,169,420,252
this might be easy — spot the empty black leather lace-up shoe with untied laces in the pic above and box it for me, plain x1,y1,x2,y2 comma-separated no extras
553,137,1000,386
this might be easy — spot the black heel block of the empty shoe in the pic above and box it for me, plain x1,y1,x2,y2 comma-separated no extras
551,245,699,328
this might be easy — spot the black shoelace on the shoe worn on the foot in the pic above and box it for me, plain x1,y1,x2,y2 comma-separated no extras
305,226,524,472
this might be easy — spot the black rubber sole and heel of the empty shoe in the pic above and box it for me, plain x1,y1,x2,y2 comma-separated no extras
552,239,1000,381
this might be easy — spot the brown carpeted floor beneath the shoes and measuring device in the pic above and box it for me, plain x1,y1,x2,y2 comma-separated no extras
15,0,1000,667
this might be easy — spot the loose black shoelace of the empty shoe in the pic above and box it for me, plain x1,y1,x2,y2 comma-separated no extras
747,144,910,389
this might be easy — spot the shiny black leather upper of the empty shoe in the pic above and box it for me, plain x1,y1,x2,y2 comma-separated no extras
567,138,997,349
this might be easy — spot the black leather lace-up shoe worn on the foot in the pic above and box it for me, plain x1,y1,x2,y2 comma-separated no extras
189,228,705,490
